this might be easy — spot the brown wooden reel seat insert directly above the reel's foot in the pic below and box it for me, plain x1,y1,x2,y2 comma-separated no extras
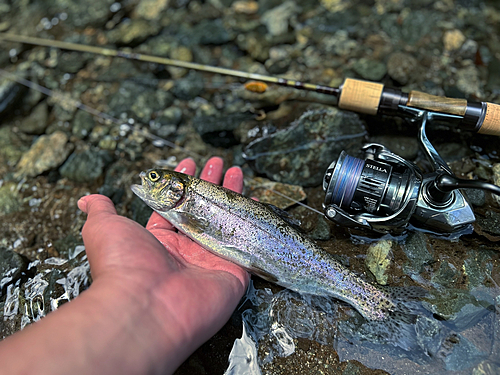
406,90,467,116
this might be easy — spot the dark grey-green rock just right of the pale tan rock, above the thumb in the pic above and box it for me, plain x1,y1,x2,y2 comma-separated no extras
59,149,112,182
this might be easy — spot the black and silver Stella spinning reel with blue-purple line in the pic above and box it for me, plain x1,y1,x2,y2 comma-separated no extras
323,106,500,233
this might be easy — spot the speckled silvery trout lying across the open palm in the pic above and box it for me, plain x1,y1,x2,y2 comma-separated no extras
132,169,394,320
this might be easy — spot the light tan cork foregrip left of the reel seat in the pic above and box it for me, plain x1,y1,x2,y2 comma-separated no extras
339,78,384,115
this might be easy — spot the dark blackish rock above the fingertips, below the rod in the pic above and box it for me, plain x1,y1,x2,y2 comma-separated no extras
193,113,253,148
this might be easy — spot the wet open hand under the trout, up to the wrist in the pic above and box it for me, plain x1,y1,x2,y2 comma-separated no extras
78,158,249,372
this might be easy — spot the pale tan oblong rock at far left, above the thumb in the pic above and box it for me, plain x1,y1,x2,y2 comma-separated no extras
16,131,73,177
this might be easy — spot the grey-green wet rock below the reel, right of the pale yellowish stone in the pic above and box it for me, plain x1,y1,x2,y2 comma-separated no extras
402,232,434,276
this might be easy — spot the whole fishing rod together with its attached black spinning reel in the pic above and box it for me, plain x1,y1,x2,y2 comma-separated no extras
0,33,500,233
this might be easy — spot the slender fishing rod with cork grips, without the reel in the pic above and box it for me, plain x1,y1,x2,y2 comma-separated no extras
0,33,500,136
